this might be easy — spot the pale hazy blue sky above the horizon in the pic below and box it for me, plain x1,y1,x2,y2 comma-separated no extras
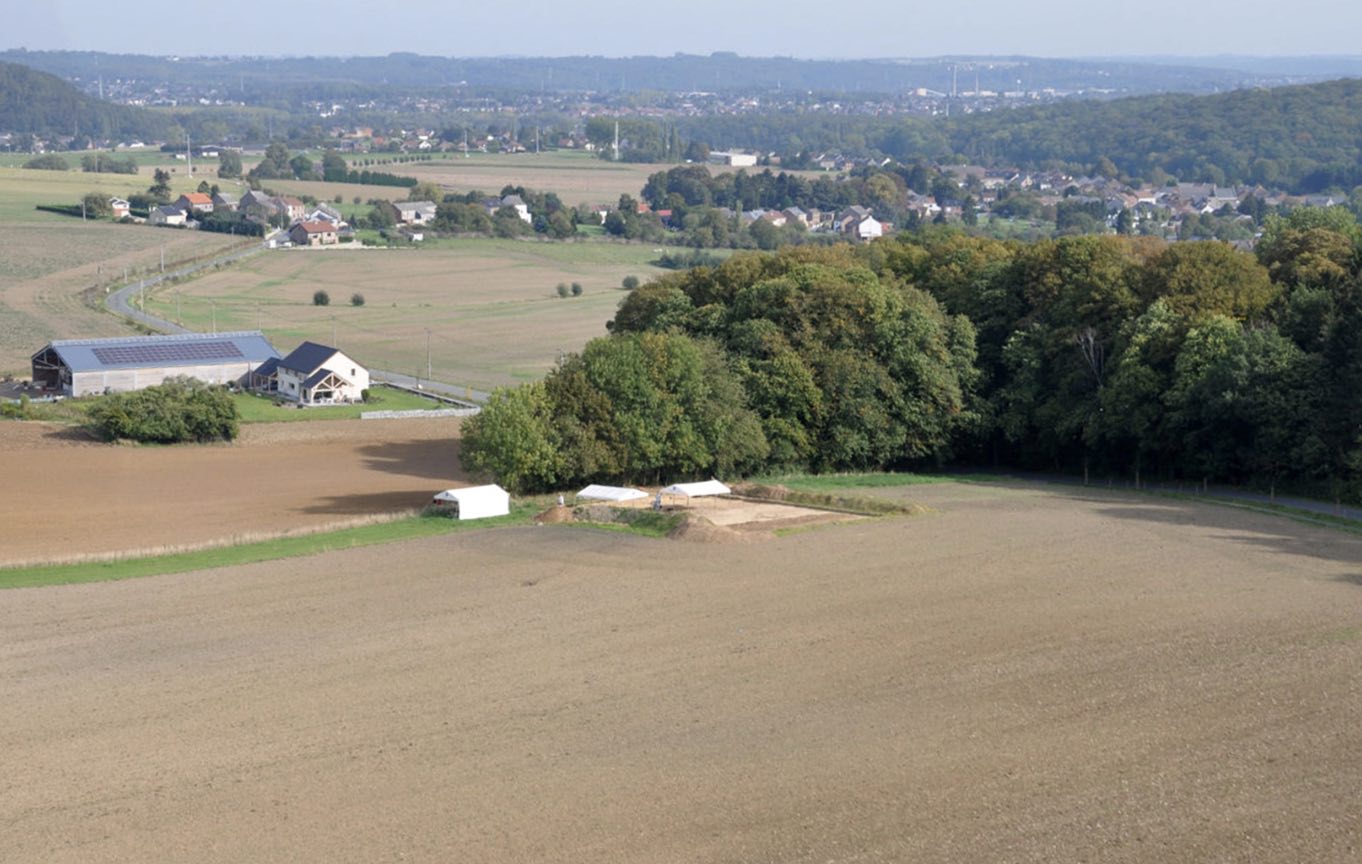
10,0,1362,57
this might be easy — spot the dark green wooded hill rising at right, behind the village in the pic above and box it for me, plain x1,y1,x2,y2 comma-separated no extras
931,79,1362,194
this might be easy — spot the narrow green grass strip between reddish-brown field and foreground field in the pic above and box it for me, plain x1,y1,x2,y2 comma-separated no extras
0,502,542,589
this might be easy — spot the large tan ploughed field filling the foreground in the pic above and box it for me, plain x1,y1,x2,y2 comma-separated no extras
0,484,1362,864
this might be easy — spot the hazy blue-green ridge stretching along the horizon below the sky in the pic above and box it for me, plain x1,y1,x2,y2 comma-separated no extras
0,50,1299,102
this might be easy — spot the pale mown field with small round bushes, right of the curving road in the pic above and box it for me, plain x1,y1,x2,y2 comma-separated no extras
147,238,675,390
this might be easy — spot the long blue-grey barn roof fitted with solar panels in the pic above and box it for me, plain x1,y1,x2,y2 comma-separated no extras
38,330,279,372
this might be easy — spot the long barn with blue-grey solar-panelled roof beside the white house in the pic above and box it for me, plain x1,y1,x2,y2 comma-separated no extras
33,330,279,397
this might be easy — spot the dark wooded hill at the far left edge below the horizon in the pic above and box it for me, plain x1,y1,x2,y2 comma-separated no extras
0,63,172,138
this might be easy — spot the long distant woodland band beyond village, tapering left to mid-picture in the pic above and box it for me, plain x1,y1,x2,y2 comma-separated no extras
653,79,1362,194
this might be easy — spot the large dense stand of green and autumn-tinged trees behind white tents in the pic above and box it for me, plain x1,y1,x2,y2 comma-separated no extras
464,210,1362,500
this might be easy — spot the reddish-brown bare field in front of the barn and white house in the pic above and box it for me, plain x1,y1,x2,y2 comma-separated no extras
0,417,462,564
